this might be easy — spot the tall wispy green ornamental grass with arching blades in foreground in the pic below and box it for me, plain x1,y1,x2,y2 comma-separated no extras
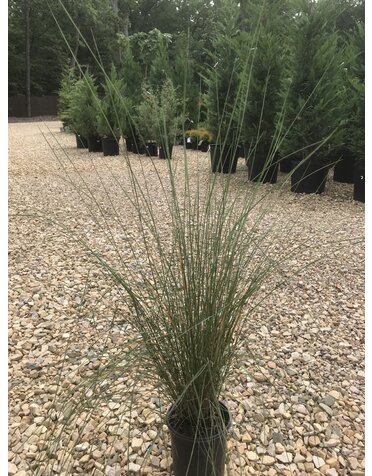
13,1,364,476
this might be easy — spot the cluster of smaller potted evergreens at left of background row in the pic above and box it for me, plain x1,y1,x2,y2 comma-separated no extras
60,66,180,158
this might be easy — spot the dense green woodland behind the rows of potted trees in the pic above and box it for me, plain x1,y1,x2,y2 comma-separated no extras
8,0,364,96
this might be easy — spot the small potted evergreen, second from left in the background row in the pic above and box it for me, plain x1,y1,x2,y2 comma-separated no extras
70,72,102,152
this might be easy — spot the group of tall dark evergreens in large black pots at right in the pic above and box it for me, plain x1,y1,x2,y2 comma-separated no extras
202,3,364,201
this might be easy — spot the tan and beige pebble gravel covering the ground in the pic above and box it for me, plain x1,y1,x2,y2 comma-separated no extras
8,121,365,476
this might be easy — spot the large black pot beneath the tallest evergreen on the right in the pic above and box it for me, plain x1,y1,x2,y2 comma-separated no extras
291,159,329,194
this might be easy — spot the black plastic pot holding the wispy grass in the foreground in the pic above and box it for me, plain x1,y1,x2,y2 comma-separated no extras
167,403,231,476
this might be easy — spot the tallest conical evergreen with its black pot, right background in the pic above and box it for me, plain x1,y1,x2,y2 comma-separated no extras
281,3,342,193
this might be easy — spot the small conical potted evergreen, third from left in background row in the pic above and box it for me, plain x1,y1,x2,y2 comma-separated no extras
97,65,128,156
